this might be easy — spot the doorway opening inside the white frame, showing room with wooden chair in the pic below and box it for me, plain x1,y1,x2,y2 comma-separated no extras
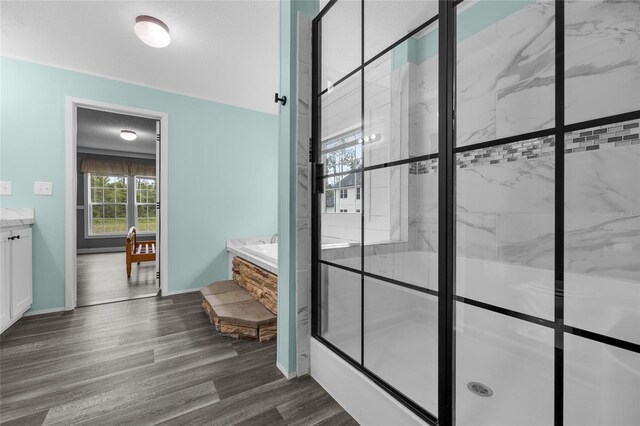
76,108,159,306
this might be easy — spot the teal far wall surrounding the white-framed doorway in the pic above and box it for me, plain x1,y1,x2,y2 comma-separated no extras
0,57,278,310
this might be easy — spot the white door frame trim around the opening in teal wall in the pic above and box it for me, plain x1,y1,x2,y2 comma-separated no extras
64,96,169,311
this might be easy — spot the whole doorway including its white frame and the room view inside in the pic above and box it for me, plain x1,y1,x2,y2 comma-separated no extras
65,98,167,310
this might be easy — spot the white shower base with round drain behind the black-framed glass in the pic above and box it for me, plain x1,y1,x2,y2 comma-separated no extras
321,248,640,425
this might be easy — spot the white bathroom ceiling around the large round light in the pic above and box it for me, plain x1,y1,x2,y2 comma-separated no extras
0,0,280,114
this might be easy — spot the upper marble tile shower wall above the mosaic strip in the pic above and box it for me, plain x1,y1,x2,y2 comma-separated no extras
452,0,640,146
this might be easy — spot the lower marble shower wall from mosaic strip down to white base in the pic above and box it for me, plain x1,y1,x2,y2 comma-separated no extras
448,116,640,279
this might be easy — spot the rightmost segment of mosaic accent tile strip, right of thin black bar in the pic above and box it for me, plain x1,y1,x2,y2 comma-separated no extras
564,120,640,154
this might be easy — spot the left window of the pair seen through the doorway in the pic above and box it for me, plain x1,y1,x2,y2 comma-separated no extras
88,174,128,235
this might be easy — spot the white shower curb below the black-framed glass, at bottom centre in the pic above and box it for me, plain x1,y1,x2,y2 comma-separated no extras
310,338,425,426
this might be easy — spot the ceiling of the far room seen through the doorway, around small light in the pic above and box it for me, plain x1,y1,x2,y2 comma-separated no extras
76,108,156,157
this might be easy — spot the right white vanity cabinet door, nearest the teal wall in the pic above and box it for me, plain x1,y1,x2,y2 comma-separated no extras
10,228,33,318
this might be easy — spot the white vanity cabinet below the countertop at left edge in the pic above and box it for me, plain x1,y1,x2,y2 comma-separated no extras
0,225,33,333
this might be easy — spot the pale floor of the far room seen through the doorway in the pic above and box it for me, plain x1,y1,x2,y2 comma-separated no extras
77,252,158,306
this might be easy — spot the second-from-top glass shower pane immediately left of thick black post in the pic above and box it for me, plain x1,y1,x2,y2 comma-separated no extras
362,37,438,166
